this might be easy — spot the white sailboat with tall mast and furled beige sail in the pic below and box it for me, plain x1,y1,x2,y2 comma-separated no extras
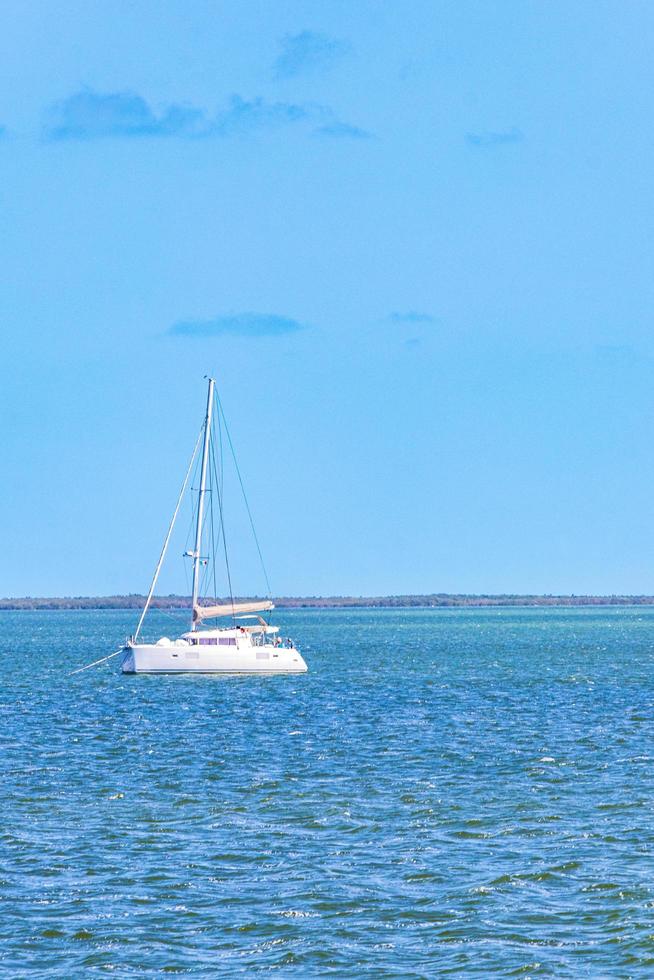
121,378,308,674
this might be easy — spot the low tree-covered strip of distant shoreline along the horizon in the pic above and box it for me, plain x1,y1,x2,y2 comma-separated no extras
0,593,654,610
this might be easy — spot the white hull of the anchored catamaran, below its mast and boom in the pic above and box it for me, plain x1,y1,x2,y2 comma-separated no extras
122,643,308,674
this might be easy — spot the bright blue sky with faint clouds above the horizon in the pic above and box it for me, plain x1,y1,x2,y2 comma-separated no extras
0,0,654,595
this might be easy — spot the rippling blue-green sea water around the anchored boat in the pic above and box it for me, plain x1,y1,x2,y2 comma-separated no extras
0,608,654,978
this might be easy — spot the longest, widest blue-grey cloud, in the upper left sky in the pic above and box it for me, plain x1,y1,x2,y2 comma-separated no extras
44,89,316,140
